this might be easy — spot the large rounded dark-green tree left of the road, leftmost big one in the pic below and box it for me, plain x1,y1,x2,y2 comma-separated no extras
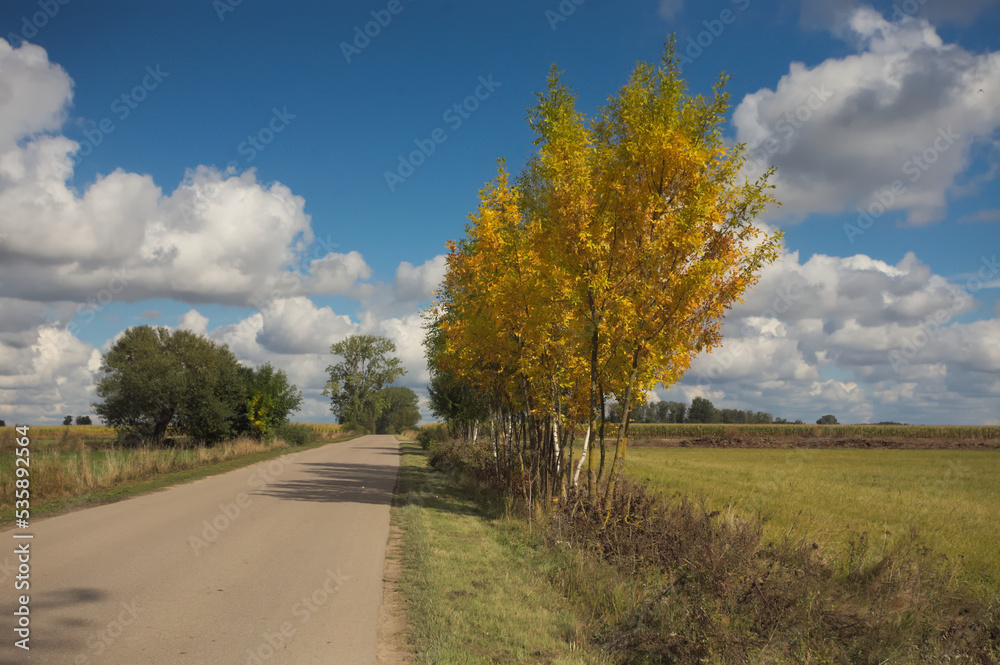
93,326,244,444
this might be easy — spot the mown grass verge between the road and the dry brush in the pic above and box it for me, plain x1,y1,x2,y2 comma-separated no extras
393,441,612,664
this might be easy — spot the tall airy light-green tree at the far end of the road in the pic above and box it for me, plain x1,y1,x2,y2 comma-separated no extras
323,335,406,432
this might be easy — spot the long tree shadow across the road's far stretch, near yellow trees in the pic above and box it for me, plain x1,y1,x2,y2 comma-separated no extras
252,462,398,505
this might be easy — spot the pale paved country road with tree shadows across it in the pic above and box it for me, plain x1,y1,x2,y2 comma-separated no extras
0,436,399,665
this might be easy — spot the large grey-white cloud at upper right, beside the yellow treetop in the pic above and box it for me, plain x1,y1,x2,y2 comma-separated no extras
733,8,1000,224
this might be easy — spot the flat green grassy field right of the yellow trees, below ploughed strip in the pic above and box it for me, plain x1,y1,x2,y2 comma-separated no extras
628,448,1000,595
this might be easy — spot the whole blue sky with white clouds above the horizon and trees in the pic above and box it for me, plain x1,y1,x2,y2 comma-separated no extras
0,0,1000,424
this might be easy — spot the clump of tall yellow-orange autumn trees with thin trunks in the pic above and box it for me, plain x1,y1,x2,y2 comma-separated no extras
430,40,781,508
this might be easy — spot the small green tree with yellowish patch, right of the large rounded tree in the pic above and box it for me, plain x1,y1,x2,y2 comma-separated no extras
240,363,302,438
